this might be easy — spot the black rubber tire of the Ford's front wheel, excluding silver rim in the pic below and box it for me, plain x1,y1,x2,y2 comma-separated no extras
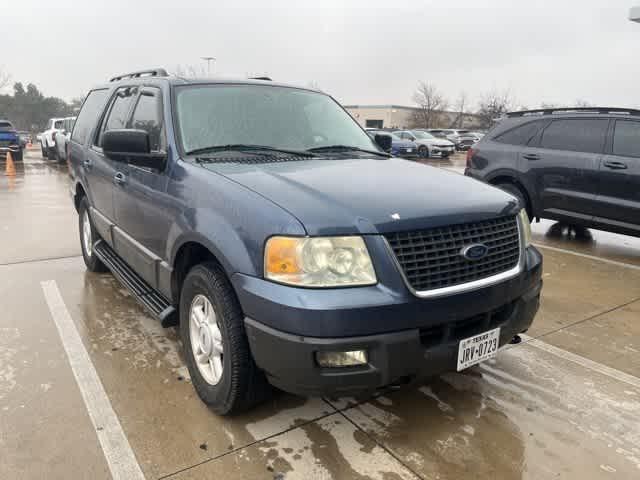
180,262,272,415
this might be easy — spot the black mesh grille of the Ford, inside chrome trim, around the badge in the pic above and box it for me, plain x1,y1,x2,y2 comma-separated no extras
385,217,520,291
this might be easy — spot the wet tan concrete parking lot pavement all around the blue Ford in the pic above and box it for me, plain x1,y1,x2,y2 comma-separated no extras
0,148,640,479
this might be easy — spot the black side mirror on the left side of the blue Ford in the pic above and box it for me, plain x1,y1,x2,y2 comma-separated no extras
102,129,167,170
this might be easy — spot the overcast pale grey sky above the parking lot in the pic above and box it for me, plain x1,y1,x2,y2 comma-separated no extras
5,0,640,107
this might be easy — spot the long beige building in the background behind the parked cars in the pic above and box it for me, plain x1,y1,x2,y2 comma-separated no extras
344,105,480,128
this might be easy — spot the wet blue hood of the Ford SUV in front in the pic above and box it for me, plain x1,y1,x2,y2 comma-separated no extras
202,158,518,235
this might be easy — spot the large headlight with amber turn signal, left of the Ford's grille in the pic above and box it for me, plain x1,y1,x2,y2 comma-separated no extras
264,237,377,288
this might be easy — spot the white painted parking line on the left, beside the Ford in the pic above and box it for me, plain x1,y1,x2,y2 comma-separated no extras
40,280,144,480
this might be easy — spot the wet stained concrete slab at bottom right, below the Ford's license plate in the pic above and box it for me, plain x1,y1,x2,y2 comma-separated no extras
332,346,640,479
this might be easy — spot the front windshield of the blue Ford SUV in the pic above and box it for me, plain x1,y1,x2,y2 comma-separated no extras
176,85,379,152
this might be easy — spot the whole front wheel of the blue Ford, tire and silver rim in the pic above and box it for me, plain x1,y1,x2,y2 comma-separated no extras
180,262,271,415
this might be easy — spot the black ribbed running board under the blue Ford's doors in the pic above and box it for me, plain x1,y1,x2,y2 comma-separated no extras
93,240,178,328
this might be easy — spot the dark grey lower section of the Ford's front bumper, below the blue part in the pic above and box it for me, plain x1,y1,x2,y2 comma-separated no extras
245,282,542,396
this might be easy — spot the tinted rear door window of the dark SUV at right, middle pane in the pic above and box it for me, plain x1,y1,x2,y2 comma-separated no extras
540,119,609,153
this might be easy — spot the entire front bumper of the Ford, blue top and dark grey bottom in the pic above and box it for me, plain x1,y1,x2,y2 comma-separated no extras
238,247,542,395
